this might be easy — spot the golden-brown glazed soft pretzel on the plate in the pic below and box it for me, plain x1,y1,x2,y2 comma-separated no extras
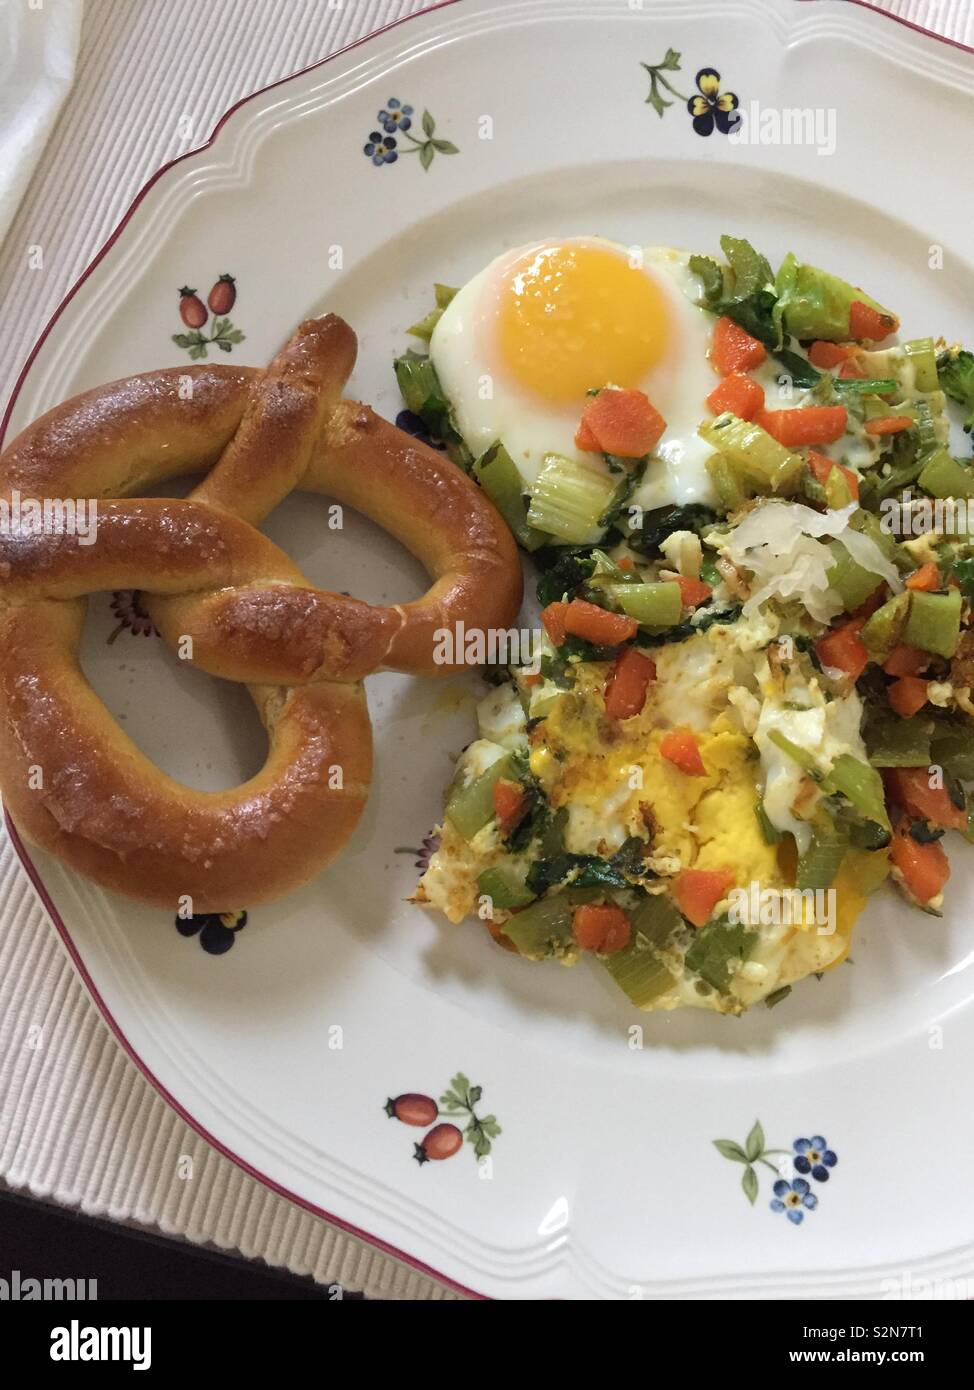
0,316,521,912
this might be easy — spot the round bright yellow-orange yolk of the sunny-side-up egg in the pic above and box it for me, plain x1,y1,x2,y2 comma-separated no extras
497,246,670,402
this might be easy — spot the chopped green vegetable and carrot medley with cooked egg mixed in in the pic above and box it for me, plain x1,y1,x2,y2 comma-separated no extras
396,236,974,1013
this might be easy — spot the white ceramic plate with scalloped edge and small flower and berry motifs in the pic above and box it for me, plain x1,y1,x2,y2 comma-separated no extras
7,0,974,1298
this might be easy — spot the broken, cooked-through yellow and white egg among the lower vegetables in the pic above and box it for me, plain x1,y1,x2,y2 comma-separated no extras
417,623,886,1013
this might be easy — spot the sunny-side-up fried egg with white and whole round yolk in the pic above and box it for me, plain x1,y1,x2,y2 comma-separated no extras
429,236,717,509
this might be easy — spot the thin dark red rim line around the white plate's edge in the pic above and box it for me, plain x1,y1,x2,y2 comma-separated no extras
0,0,974,1298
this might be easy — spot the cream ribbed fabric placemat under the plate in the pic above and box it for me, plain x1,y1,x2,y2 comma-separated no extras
0,0,974,1300
